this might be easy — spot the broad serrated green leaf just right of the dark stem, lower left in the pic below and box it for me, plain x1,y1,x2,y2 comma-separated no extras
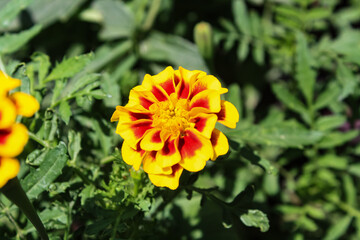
21,142,68,199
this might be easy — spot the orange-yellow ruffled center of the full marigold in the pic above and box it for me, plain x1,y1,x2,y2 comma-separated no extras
150,99,190,134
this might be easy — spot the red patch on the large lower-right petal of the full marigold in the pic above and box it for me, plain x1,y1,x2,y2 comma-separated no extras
179,131,202,158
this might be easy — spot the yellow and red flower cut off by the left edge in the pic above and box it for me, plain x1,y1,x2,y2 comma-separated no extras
0,71,40,188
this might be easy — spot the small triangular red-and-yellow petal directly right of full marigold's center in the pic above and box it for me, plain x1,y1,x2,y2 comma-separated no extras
190,113,217,138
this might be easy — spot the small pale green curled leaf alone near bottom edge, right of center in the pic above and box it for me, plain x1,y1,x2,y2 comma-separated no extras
240,209,270,232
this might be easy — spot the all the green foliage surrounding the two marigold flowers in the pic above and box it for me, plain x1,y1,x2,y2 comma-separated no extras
0,0,360,240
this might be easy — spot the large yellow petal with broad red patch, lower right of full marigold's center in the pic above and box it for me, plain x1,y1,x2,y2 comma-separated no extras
178,129,213,172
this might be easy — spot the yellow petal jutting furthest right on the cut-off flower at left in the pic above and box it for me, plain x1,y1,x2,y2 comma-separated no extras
10,92,40,117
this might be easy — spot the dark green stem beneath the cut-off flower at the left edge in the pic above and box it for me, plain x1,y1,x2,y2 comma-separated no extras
0,177,49,240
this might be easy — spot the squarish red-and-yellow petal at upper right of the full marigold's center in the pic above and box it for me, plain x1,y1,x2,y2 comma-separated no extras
190,90,221,115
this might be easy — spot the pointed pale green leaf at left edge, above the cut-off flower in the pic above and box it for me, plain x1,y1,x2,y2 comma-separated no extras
0,25,41,55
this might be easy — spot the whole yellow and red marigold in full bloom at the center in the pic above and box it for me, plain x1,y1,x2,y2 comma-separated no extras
111,67,239,189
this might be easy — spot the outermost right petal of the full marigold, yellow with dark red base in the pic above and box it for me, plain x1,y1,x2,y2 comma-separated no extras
217,100,239,128
